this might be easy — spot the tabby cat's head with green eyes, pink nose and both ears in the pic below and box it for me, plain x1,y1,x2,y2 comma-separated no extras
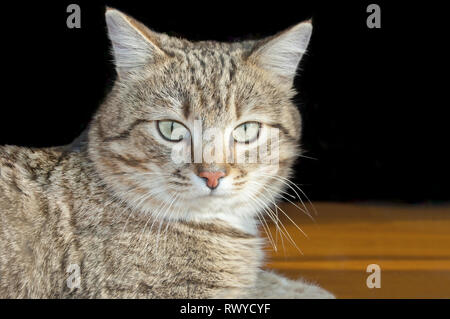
89,9,312,234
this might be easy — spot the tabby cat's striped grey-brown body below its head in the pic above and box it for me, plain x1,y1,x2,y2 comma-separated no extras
0,147,262,298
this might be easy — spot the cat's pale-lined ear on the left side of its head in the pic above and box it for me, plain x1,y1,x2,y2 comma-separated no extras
105,8,165,75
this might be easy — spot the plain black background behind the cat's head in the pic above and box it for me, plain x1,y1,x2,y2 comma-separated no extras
0,0,450,203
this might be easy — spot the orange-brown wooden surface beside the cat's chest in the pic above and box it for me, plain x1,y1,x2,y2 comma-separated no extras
267,203,450,298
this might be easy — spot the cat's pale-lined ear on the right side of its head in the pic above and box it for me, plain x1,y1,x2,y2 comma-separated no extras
249,20,312,83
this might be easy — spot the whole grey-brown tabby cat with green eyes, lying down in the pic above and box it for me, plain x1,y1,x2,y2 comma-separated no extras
0,8,334,298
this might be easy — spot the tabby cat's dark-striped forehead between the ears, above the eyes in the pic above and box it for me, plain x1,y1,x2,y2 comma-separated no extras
137,41,280,127
